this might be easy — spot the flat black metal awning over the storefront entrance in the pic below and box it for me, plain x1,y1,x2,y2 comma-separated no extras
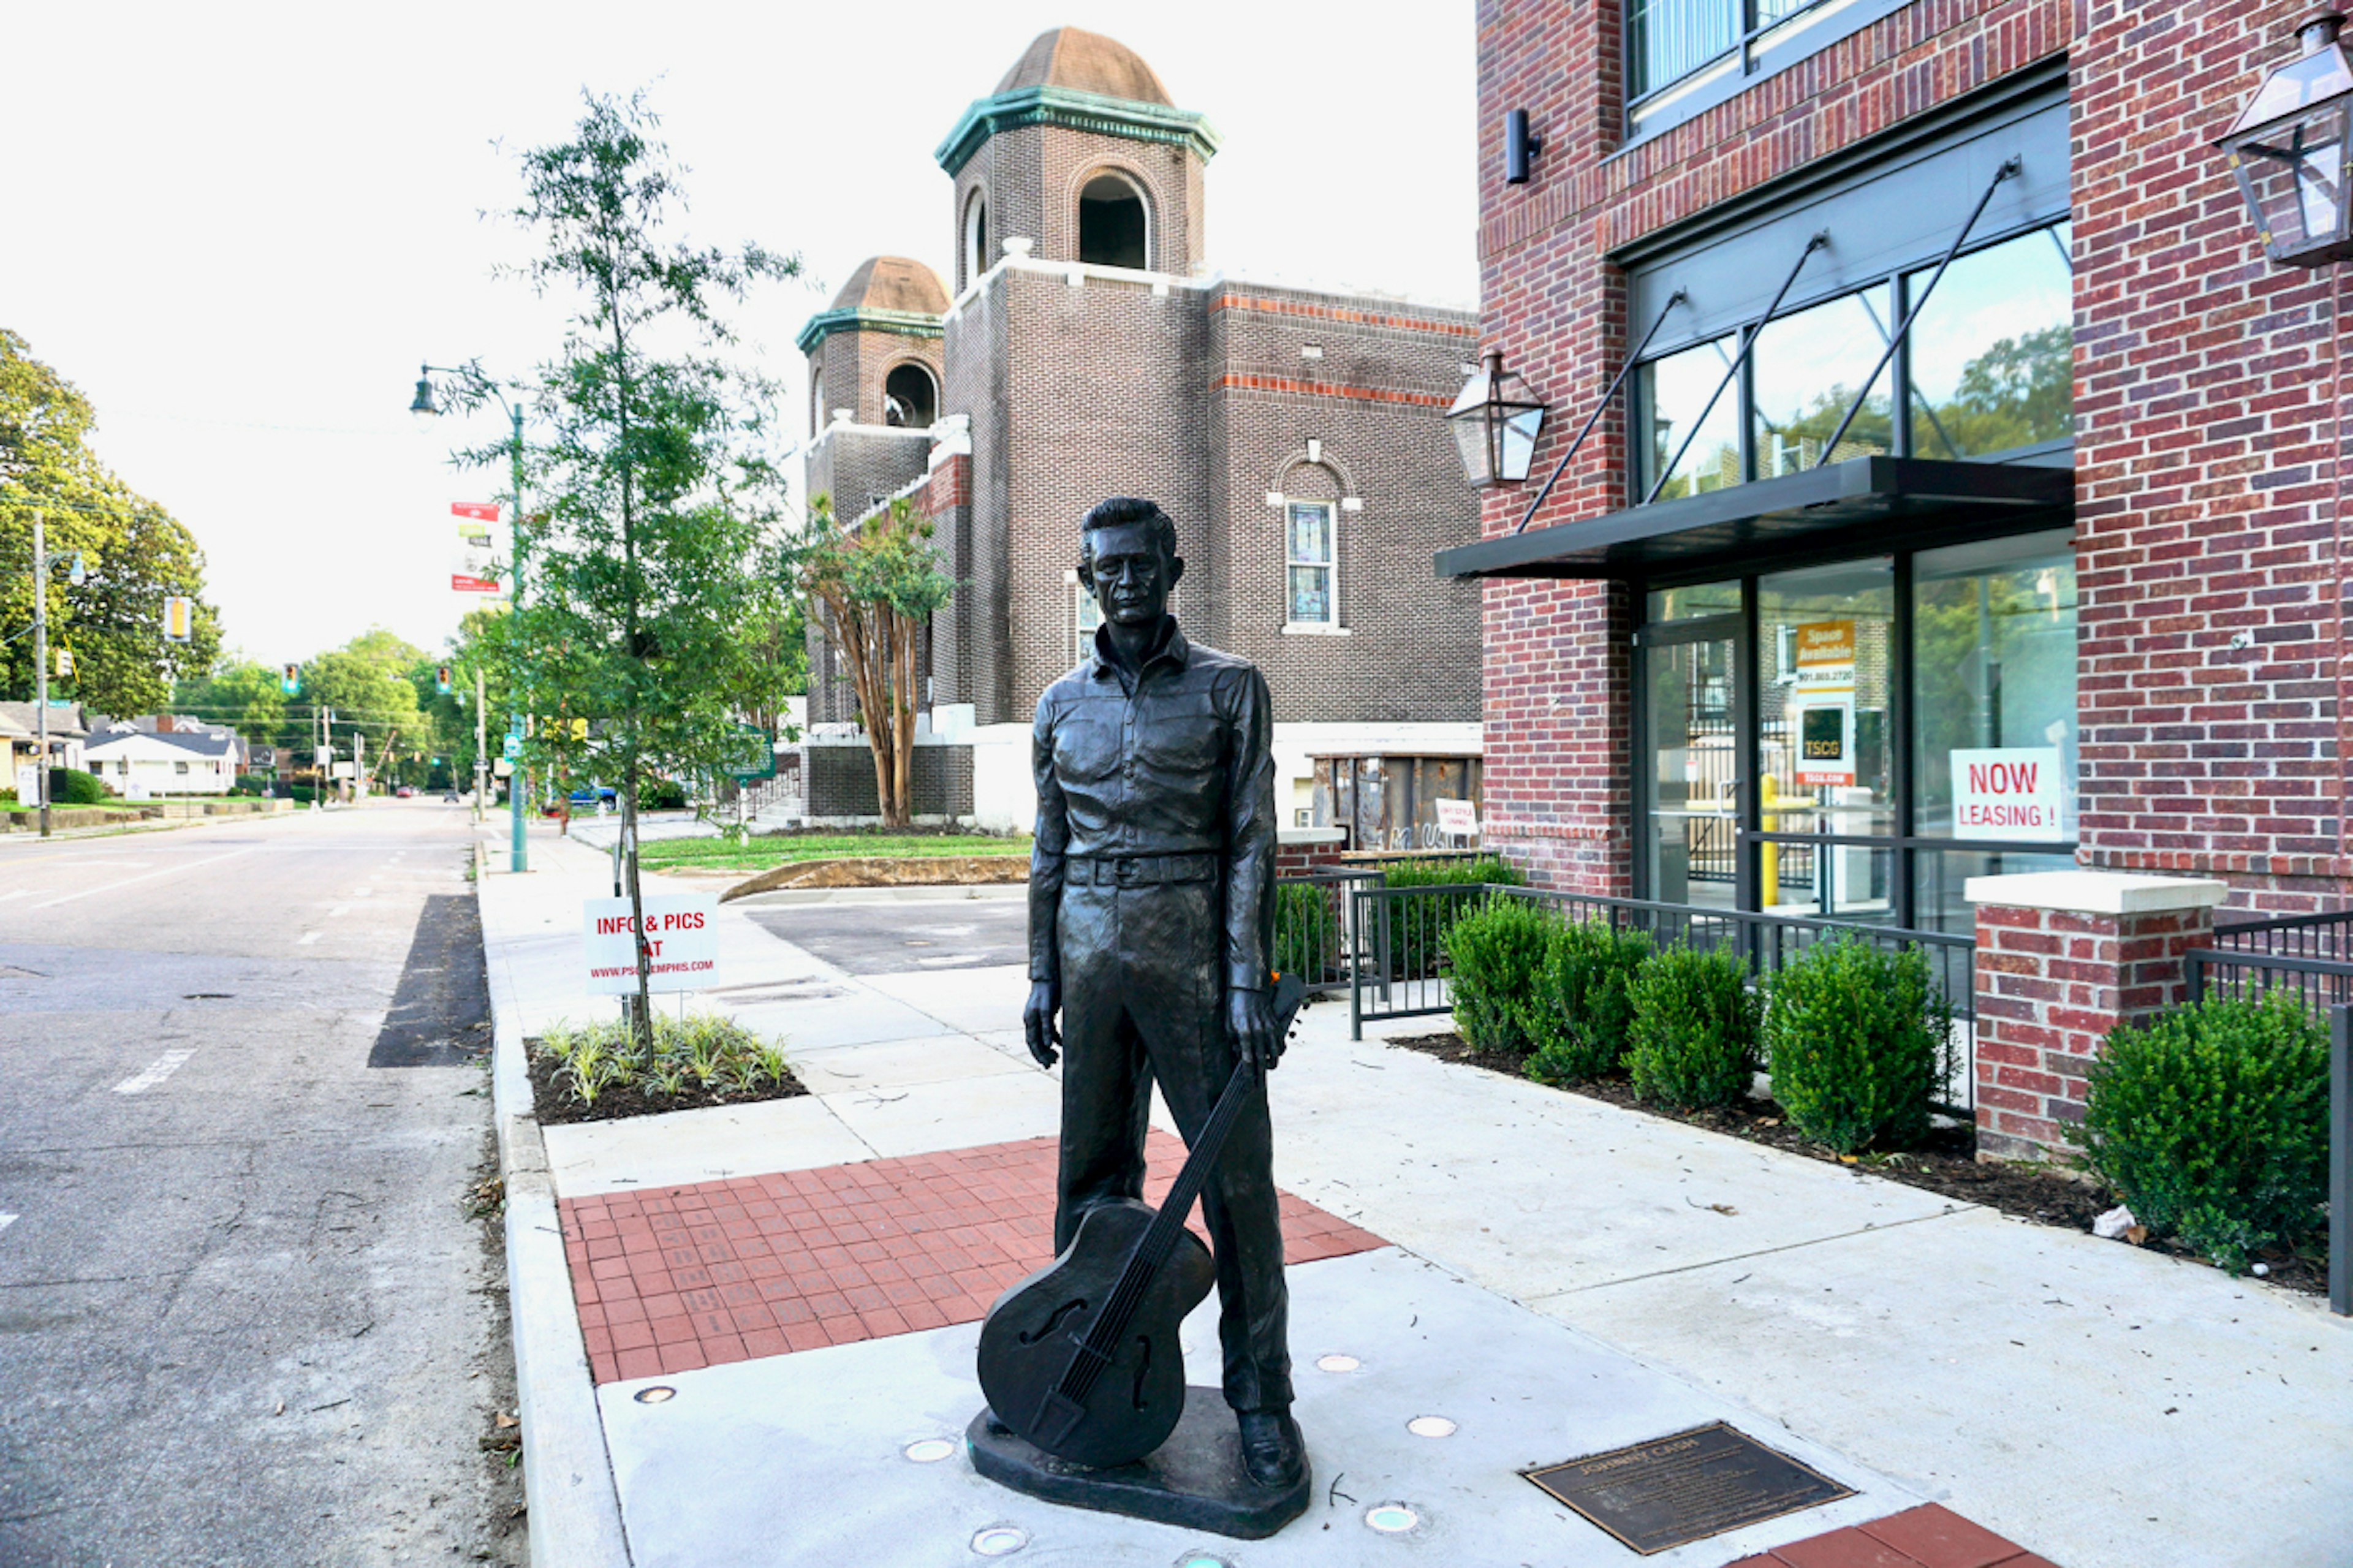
1435,456,2075,577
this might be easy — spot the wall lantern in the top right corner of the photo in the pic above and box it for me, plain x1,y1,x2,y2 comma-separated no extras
2216,12,2353,266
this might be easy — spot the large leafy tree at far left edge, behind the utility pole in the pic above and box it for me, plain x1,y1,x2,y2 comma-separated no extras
0,327,221,713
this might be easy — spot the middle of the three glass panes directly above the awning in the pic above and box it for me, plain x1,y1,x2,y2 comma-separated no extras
1751,287,1894,478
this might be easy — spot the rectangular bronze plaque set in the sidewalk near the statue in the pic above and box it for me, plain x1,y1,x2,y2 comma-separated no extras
1520,1422,1854,1556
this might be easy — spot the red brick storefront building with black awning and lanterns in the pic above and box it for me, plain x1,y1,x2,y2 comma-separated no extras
1438,0,2353,1149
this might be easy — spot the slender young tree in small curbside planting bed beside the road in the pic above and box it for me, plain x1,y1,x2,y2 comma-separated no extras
452,94,800,1048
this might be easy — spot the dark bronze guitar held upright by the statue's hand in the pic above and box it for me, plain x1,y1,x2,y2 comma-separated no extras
979,975,1306,1467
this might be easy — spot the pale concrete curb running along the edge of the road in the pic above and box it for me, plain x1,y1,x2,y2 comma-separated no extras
473,838,631,1568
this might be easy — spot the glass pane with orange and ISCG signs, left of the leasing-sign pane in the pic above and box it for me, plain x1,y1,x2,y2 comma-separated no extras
1757,556,1896,920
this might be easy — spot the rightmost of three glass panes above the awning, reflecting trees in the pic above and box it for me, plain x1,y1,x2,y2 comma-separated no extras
1906,224,2075,456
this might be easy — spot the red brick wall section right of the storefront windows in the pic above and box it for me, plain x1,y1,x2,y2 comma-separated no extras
2071,0,2353,911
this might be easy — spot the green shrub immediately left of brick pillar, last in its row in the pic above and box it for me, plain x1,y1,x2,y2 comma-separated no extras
1765,937,1950,1154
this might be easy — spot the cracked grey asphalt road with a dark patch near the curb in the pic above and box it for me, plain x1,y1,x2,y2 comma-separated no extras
0,800,525,1568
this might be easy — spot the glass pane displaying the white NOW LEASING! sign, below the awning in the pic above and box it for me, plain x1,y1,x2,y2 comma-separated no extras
1913,530,2078,843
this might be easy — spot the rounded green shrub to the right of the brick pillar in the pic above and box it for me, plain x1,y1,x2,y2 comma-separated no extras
2064,991,2330,1274
